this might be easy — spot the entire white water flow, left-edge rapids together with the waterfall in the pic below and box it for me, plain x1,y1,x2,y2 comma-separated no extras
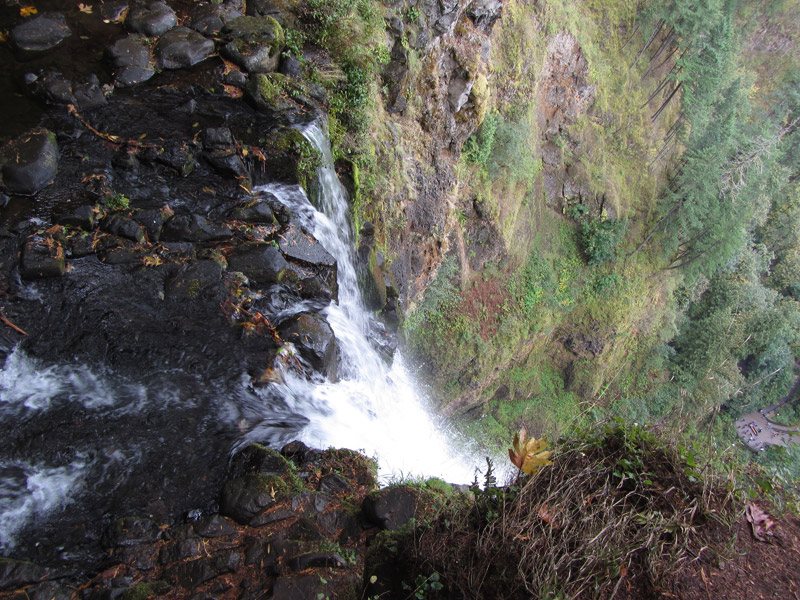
0,118,482,551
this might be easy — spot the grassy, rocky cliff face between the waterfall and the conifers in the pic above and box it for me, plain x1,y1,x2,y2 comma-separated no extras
384,2,671,426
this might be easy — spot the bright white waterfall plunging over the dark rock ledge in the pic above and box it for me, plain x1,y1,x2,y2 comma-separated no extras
262,121,478,483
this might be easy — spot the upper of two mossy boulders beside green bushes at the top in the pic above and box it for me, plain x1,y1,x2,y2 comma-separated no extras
220,17,285,73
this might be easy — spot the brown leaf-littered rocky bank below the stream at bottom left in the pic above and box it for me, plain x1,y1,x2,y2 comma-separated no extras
32,442,377,600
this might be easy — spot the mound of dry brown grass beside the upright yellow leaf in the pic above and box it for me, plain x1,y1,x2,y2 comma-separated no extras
406,426,733,599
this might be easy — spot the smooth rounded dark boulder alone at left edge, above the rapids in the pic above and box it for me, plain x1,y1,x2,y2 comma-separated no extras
2,128,58,196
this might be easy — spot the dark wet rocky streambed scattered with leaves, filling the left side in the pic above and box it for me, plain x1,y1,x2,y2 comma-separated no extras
0,1,400,598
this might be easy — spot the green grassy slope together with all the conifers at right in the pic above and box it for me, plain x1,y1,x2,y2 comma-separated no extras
392,0,800,488
